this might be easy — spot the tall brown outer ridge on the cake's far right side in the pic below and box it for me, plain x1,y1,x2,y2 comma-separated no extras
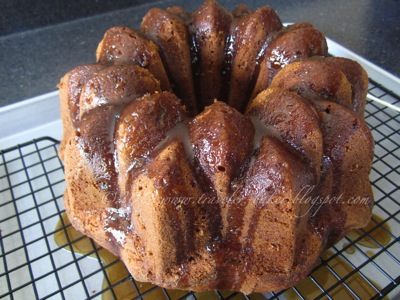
311,101,374,247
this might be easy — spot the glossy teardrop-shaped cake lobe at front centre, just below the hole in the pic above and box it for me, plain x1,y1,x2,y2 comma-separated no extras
189,101,254,199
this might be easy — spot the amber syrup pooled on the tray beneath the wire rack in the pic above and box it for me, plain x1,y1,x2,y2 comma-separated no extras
54,213,391,300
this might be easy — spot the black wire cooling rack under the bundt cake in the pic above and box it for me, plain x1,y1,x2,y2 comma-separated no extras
0,78,400,300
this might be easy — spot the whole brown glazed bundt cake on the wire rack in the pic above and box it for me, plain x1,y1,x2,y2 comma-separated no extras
59,0,374,293
